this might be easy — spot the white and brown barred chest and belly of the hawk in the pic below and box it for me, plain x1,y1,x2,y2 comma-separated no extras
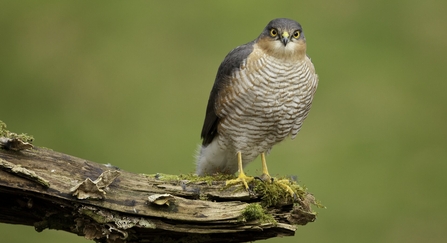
216,52,318,157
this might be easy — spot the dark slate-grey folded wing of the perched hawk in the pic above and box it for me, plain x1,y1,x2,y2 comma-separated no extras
201,41,254,146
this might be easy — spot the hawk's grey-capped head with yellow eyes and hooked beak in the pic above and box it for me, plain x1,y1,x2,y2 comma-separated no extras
256,19,306,60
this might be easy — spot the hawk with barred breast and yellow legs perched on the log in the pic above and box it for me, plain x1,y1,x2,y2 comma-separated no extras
196,18,318,192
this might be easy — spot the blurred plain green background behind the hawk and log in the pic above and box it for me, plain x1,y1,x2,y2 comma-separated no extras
0,0,447,243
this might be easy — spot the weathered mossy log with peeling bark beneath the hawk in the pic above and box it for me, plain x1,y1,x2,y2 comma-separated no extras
0,121,316,242
